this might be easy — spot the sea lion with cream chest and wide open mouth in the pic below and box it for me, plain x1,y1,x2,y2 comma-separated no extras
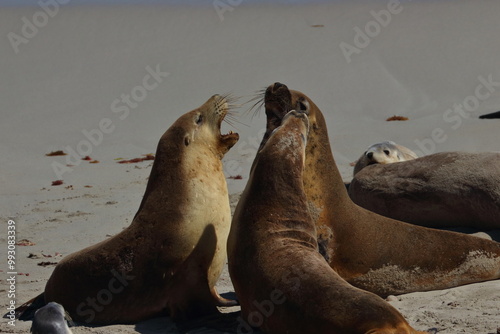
18,95,239,325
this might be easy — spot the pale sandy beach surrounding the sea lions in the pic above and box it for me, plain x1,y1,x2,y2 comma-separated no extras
0,0,500,334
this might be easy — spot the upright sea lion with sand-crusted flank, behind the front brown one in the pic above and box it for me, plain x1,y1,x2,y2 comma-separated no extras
261,83,500,297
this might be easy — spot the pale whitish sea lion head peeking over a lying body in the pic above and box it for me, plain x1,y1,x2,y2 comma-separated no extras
354,141,418,175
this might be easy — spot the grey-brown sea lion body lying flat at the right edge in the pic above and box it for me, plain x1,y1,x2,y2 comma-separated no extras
349,152,500,230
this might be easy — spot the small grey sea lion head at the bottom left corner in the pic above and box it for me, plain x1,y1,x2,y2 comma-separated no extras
31,302,73,334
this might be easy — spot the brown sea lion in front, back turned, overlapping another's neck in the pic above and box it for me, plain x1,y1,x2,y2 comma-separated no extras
228,111,423,334
